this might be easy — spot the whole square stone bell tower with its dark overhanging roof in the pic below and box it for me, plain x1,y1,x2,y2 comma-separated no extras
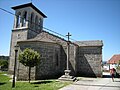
9,3,47,72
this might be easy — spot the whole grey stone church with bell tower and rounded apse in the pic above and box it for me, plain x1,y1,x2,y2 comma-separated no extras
9,3,103,80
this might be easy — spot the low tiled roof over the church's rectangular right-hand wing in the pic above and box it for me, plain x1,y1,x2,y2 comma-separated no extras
75,40,103,46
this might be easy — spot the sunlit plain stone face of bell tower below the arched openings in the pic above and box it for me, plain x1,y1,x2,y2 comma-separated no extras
9,29,27,74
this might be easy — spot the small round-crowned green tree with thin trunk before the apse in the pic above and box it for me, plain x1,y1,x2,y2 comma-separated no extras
19,48,40,83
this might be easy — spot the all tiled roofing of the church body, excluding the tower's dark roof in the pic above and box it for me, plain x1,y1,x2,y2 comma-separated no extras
17,30,103,46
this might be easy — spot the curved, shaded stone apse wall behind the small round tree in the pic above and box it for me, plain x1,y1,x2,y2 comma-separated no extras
18,41,66,80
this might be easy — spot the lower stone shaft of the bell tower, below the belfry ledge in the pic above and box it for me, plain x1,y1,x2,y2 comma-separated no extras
9,28,37,74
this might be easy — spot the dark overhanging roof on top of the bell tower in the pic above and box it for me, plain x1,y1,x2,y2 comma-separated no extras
12,3,47,18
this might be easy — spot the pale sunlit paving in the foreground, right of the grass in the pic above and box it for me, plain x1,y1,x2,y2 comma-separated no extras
60,73,120,90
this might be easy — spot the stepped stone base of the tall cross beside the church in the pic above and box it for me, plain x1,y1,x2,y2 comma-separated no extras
58,70,76,81
